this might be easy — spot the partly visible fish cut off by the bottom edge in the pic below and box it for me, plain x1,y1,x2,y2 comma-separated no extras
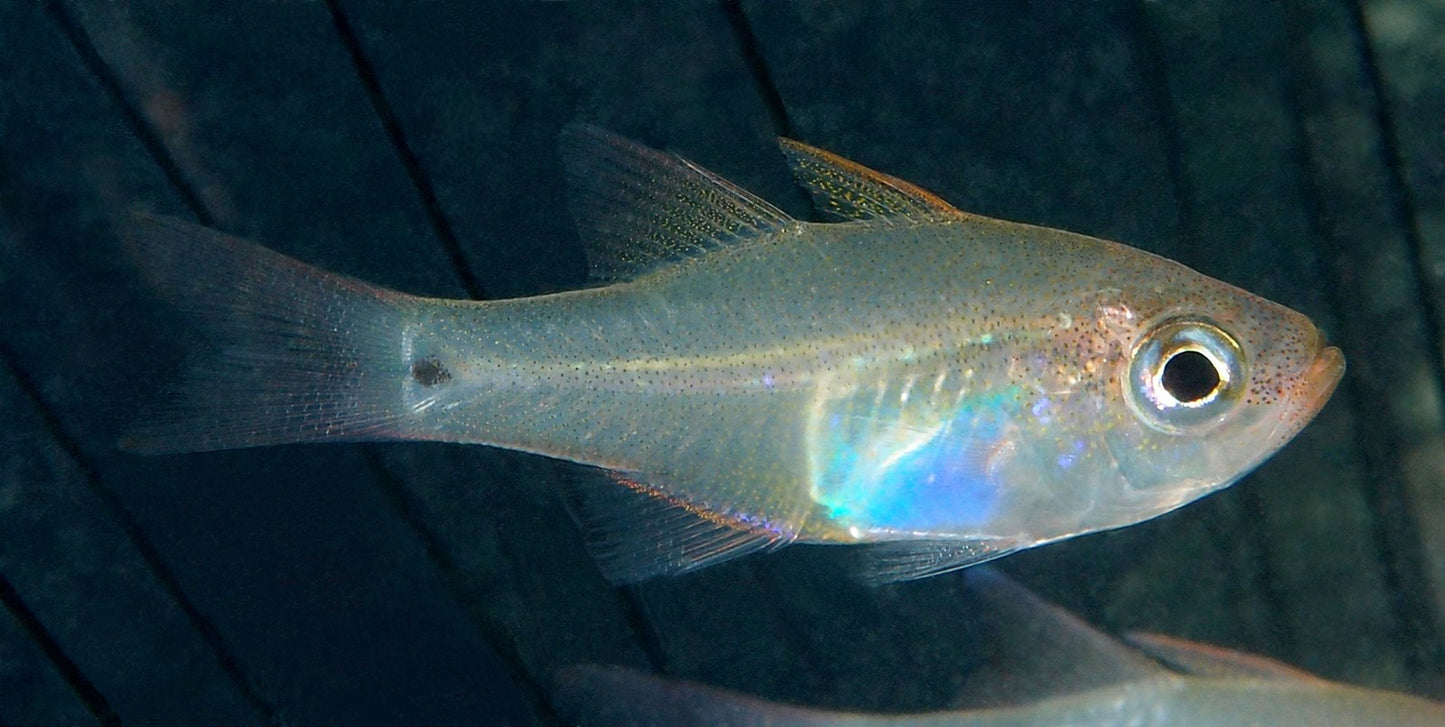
551,567,1445,727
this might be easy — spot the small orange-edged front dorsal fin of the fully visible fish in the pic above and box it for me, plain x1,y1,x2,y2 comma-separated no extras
777,139,964,223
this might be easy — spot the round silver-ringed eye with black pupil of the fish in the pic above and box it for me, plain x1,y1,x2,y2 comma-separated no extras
1124,318,1246,434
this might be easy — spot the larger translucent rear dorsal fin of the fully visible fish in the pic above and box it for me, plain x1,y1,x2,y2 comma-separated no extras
559,124,802,280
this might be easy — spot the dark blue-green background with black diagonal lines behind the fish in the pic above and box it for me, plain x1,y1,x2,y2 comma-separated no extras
0,0,1445,724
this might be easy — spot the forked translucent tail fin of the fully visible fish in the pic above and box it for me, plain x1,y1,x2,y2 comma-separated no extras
120,215,413,454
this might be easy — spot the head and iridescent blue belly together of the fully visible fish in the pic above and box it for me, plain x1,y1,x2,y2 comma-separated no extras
808,257,1344,552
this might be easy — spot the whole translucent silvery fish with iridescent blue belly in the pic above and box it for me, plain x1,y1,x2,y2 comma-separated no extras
121,124,1344,584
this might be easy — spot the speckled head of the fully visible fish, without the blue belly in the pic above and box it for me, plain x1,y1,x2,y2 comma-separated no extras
1013,270,1345,539
